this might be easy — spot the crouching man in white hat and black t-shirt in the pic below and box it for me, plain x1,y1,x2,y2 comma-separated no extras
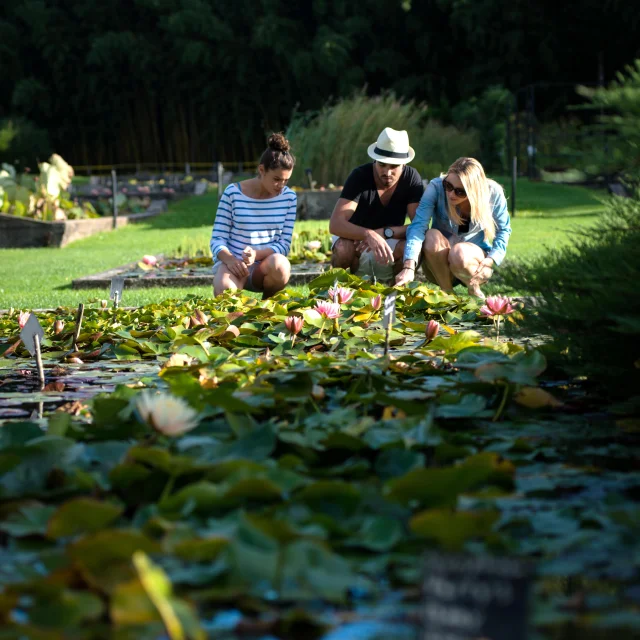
329,127,424,280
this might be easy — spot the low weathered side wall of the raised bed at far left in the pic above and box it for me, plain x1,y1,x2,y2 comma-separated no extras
0,200,167,249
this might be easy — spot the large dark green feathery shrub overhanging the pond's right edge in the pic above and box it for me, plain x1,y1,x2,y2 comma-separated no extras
503,179,640,397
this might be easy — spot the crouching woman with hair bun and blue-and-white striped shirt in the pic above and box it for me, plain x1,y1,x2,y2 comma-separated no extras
211,133,297,299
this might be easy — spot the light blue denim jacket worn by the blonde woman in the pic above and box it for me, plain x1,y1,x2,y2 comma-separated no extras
404,178,511,266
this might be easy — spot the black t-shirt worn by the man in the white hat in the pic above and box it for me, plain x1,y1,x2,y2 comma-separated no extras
340,162,424,229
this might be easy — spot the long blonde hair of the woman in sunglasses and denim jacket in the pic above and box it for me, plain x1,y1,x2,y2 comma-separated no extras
441,158,502,242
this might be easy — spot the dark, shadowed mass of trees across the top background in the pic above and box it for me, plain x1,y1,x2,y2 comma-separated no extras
0,0,640,164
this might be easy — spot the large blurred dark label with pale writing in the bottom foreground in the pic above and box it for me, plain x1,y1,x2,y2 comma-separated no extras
421,554,531,640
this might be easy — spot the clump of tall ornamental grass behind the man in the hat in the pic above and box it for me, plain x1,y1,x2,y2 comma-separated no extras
287,92,479,187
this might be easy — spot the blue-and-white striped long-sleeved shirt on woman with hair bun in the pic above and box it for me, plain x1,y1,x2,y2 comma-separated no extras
210,182,298,262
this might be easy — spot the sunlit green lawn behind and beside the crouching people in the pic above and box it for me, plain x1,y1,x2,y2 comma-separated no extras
0,179,603,309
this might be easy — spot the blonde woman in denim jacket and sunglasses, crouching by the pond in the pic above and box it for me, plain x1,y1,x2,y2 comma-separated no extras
396,158,511,298
